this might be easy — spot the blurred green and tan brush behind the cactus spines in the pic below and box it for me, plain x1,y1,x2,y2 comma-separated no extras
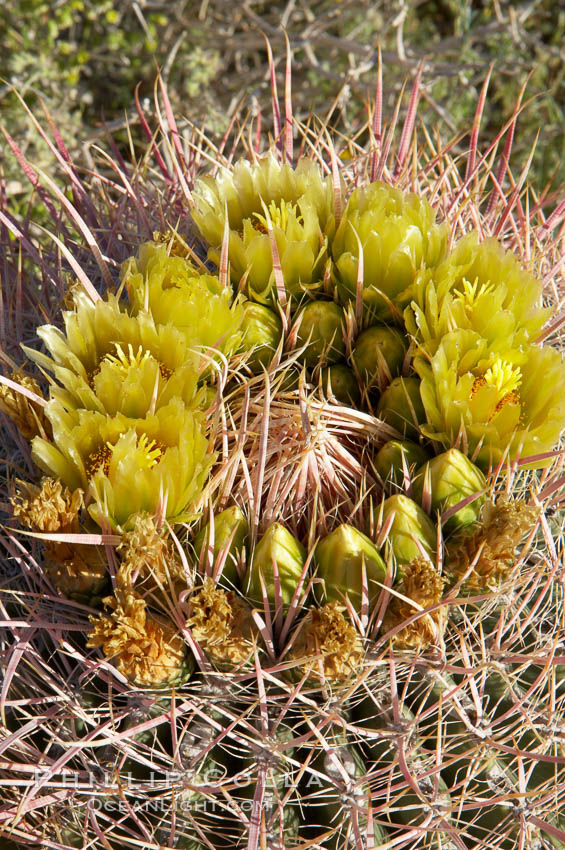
0,0,565,210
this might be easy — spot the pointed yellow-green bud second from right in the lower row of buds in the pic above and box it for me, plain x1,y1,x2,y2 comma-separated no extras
377,496,437,580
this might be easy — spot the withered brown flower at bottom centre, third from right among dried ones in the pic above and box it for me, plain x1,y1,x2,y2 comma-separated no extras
286,602,363,683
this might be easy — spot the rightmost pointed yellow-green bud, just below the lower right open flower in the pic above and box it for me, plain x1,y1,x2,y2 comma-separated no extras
414,449,487,531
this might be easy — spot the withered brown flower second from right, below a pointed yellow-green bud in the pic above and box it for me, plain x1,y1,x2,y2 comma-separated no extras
381,558,447,650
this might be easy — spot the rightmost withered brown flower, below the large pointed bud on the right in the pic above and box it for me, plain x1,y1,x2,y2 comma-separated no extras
448,496,540,591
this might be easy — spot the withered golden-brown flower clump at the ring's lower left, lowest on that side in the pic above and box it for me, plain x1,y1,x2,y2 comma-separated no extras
86,587,188,688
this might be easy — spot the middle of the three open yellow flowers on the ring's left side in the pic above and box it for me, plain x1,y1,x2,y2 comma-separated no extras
26,292,203,418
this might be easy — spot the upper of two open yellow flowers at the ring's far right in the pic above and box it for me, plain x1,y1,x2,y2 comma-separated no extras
405,233,552,354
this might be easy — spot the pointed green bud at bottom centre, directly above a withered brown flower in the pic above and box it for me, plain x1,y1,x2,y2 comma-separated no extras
314,523,386,611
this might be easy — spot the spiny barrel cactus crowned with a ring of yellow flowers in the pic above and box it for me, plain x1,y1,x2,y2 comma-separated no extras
0,43,565,850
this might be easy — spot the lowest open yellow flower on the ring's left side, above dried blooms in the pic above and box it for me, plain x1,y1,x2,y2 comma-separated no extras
32,398,214,529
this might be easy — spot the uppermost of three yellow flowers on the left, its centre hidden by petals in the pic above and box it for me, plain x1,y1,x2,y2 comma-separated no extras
121,242,243,356
